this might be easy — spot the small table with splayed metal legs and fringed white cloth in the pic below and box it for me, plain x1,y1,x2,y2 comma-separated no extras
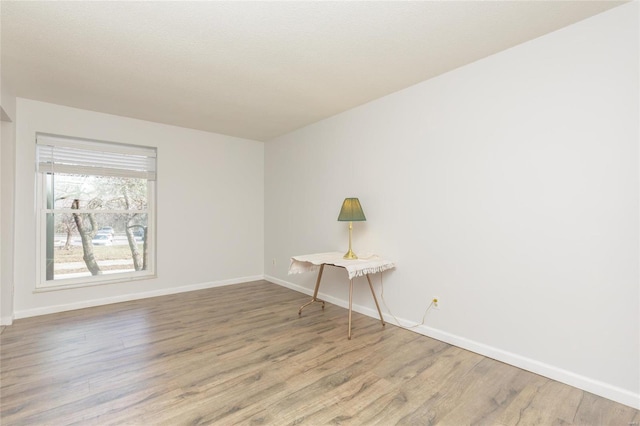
289,252,396,340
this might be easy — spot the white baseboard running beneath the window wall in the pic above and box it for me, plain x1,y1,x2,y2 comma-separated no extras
14,275,264,319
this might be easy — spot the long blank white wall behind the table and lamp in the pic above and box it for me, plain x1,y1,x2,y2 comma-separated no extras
265,2,640,408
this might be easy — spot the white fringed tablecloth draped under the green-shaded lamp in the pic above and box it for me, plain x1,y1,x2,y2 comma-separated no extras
289,252,396,280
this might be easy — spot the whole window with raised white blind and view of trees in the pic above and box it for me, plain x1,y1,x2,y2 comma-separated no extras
36,134,156,288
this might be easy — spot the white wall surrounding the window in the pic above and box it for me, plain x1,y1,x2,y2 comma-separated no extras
14,98,264,318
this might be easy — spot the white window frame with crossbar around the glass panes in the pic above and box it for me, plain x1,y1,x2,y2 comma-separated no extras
35,133,157,292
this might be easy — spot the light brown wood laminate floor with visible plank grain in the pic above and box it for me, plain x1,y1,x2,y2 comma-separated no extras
0,281,640,426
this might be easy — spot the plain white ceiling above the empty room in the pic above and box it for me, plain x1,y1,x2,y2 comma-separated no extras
0,0,622,141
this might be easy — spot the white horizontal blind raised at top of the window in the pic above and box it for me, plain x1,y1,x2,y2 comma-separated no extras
36,134,156,180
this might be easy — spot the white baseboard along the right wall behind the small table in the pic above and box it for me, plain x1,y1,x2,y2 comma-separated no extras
264,275,640,410
